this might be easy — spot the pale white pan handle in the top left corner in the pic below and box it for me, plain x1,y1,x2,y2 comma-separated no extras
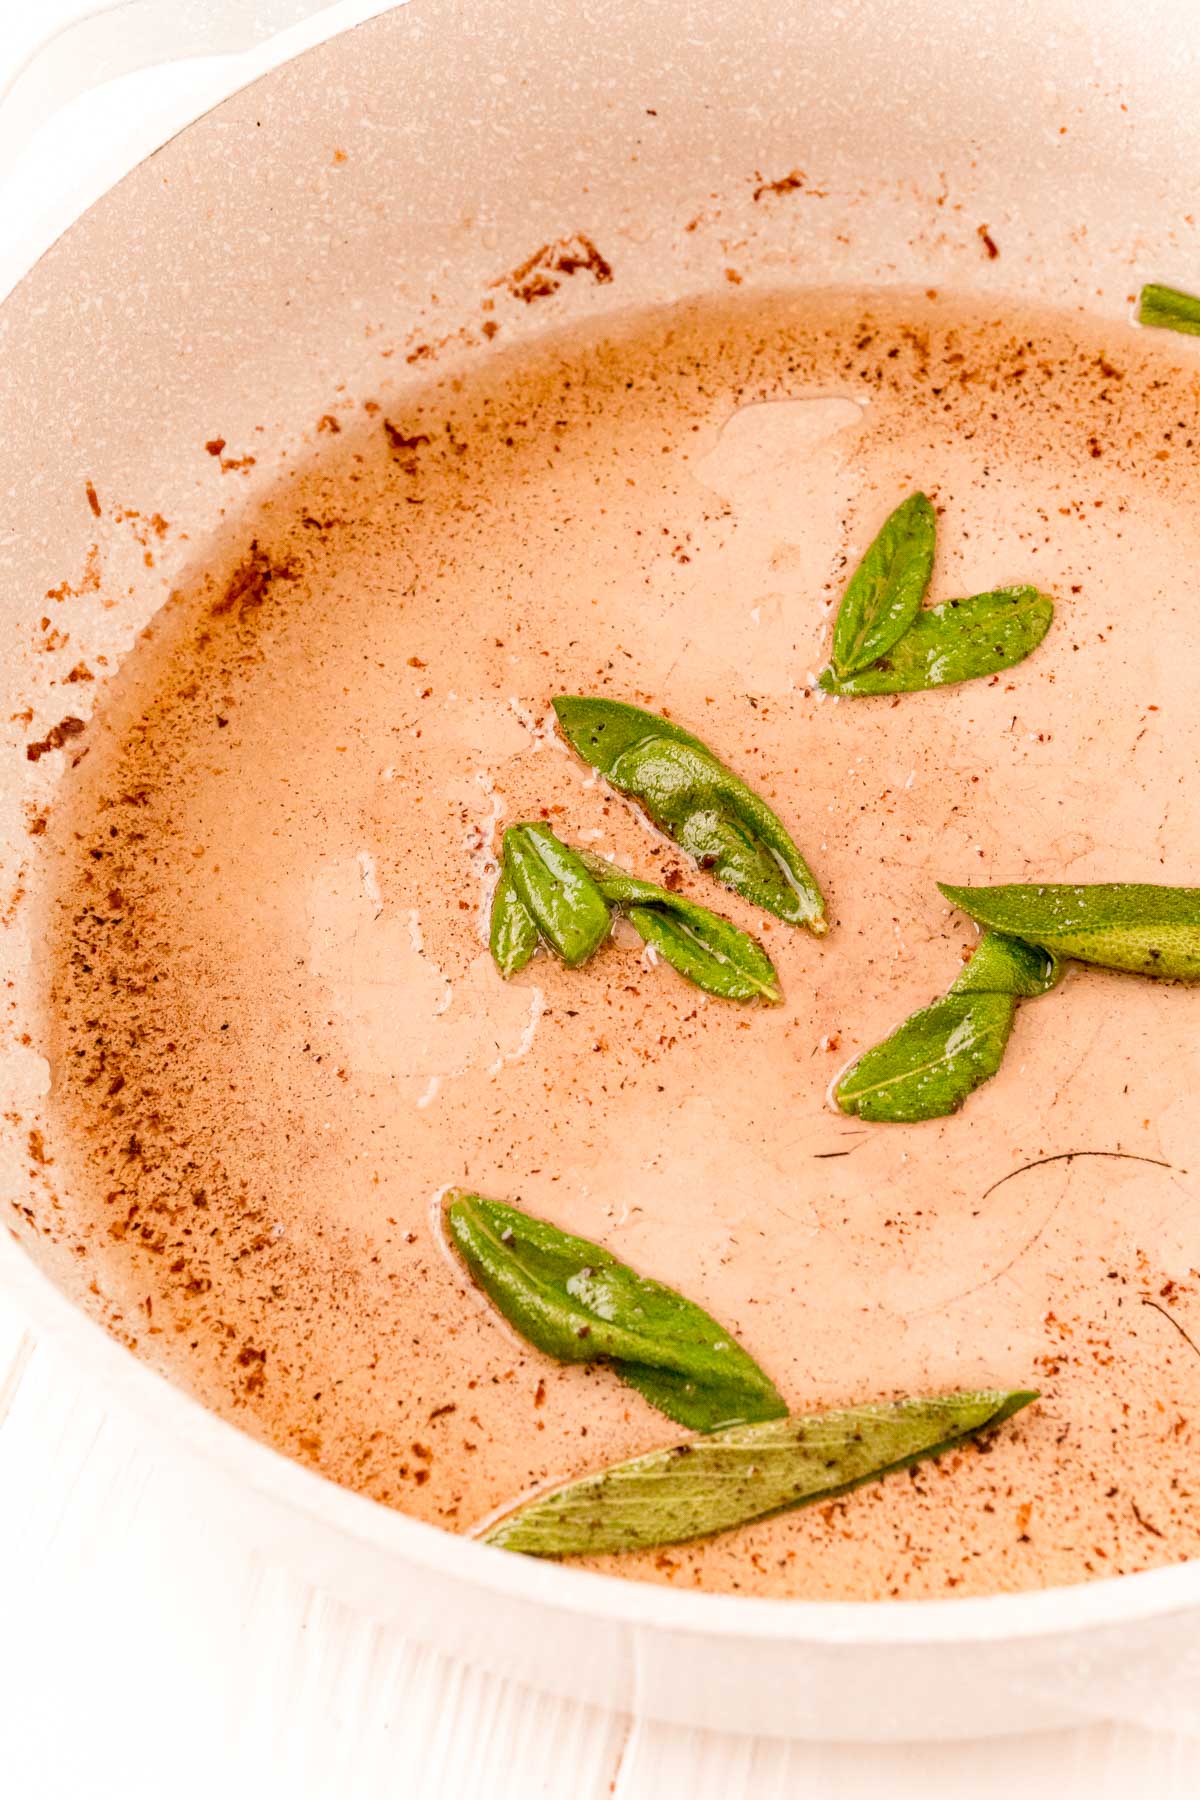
0,0,394,180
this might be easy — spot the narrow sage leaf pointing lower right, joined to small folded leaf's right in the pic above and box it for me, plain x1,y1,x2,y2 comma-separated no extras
579,850,783,1006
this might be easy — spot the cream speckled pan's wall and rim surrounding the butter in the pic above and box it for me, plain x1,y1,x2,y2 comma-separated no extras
0,0,1200,1739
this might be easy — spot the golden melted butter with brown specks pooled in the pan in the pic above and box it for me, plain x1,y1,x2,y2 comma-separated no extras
35,295,1200,1597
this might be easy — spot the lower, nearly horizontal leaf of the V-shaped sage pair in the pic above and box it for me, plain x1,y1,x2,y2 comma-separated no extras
820,587,1054,697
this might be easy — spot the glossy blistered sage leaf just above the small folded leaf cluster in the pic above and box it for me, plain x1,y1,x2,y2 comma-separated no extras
554,695,828,936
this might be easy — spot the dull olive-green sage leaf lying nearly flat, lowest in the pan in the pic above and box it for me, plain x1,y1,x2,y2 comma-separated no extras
484,1390,1036,1557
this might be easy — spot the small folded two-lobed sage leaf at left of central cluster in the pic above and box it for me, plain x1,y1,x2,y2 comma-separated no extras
491,823,612,976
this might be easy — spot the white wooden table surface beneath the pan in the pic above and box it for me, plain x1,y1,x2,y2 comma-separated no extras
0,0,1200,1800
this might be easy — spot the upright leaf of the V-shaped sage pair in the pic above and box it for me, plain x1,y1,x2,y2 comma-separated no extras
833,493,937,680
